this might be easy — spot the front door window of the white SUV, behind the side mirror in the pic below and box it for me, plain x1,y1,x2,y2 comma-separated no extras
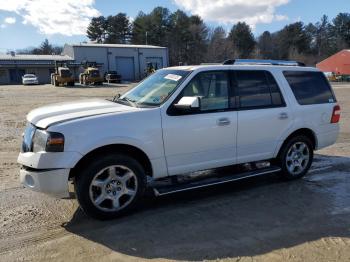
182,72,229,111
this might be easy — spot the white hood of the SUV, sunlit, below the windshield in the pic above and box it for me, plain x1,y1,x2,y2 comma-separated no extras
27,99,138,129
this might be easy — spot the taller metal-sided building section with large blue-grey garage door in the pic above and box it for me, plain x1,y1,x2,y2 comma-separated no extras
62,44,169,81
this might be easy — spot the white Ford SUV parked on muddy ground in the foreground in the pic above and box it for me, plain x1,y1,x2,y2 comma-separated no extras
18,60,340,219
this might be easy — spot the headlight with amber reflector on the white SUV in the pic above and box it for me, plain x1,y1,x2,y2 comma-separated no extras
33,129,64,153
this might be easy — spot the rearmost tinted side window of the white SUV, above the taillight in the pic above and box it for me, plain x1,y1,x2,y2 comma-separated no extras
283,71,336,105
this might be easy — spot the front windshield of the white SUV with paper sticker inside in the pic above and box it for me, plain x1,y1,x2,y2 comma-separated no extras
119,69,191,106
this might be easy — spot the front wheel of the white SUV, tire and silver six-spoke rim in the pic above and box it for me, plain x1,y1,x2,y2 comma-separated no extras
75,154,146,219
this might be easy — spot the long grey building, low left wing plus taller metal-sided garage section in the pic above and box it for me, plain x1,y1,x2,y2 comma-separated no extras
0,44,169,84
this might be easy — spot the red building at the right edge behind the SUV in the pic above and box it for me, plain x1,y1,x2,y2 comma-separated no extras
316,49,350,75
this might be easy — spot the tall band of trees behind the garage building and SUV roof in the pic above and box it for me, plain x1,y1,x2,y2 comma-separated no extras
87,7,350,65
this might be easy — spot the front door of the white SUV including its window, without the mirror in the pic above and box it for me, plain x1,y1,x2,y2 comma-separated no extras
162,71,237,175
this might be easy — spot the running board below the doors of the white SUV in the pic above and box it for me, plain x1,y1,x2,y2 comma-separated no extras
153,166,281,196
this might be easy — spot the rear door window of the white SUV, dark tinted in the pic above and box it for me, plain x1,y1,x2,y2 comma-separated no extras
236,71,283,108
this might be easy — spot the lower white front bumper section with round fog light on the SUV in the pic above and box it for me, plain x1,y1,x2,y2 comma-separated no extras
20,168,70,198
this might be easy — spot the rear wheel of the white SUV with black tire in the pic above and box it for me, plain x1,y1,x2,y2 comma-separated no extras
276,135,314,180
